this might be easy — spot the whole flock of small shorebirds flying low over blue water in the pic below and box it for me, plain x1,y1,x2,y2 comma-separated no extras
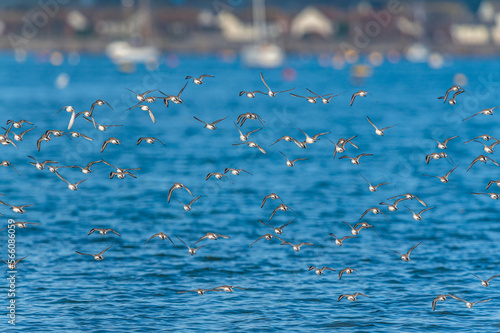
0,73,500,311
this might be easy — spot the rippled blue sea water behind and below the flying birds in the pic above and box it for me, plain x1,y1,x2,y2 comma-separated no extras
0,54,500,332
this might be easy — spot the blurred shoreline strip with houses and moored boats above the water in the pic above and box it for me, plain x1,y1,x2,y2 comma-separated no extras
0,0,500,70
